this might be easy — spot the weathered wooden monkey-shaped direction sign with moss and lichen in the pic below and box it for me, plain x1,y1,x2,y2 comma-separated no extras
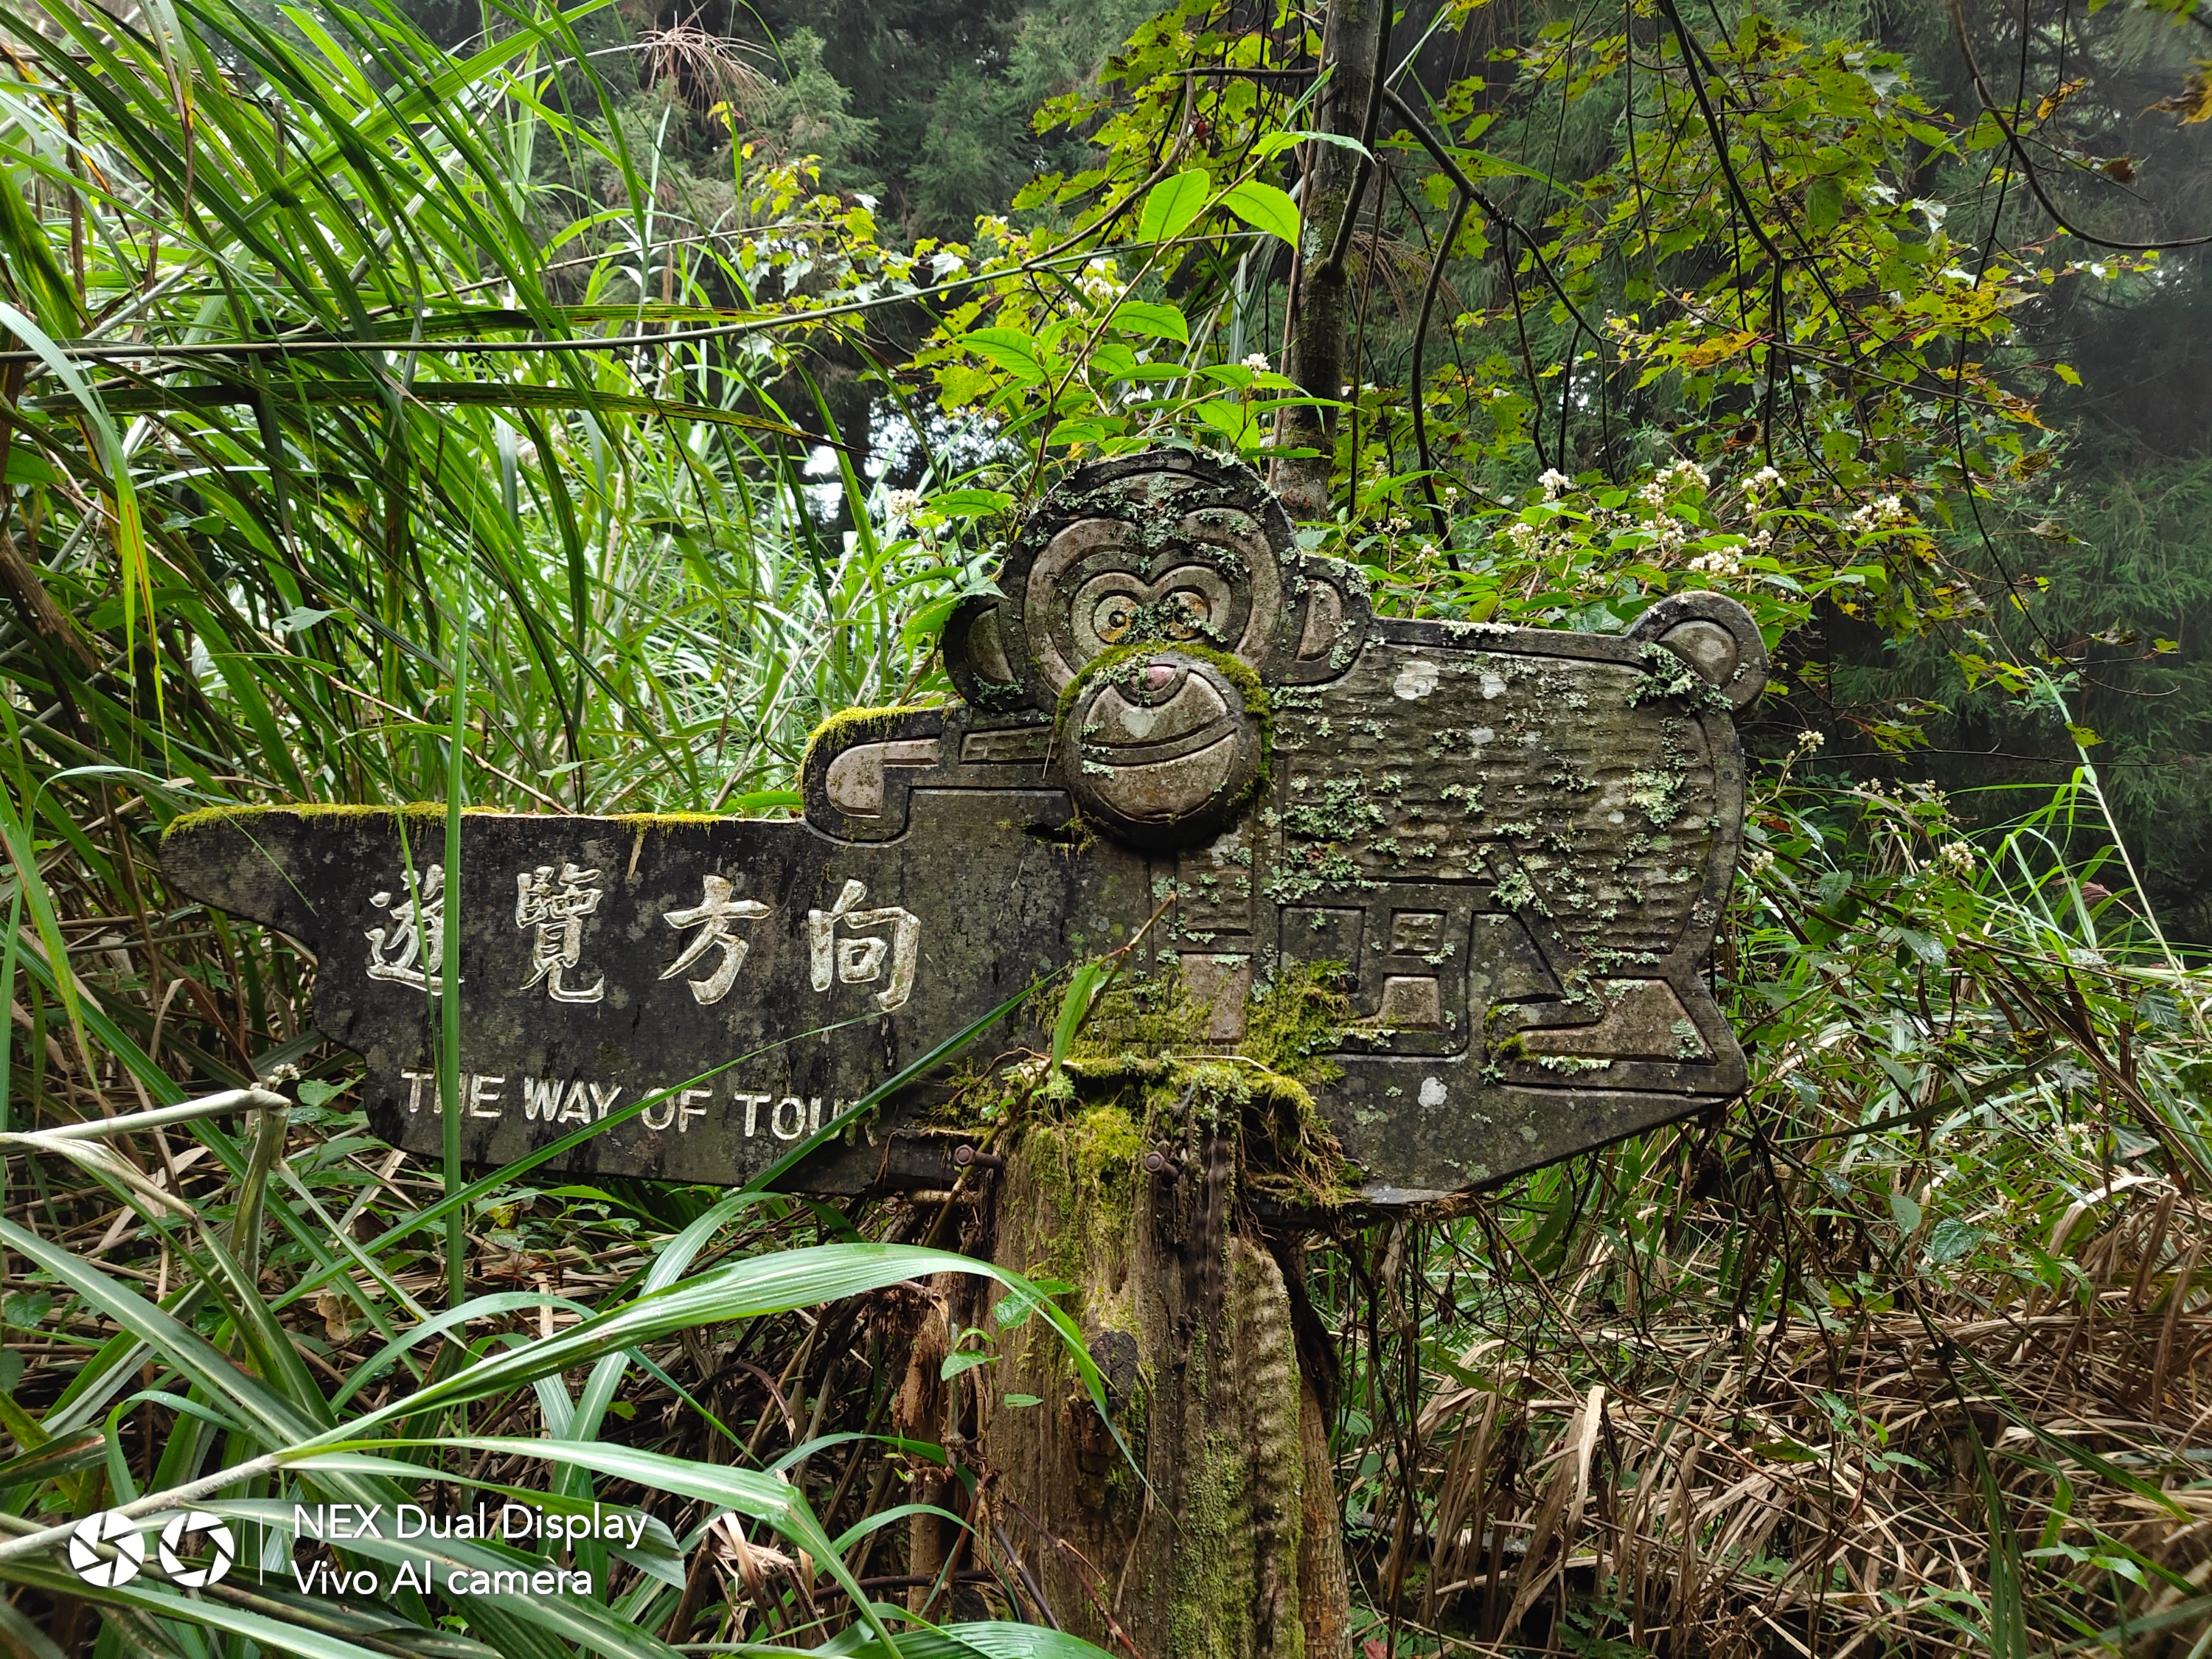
164,451,1765,1206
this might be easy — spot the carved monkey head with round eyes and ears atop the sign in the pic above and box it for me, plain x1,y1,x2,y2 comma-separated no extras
945,449,1369,847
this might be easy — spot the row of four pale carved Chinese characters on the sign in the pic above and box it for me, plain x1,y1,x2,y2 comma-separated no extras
367,860,922,1013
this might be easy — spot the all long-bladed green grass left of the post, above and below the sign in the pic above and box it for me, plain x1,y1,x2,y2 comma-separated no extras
0,0,1088,1659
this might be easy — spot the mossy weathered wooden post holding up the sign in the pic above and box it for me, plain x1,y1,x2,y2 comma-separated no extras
960,1091,1349,1659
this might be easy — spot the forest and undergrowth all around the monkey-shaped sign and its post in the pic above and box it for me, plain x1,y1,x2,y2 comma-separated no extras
0,0,2212,1659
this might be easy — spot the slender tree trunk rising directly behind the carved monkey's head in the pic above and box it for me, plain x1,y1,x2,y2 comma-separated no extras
1270,0,1391,518
